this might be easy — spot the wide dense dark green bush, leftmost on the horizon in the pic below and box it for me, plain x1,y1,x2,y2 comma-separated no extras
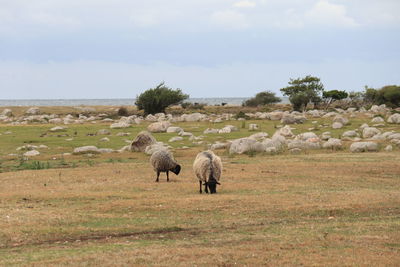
135,82,189,114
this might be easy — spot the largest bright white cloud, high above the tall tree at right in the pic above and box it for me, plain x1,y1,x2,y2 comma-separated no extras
305,0,359,27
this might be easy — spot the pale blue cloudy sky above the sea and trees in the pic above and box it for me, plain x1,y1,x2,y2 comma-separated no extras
0,0,400,99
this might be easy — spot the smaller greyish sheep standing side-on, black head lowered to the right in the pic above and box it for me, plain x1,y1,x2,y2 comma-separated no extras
150,149,181,182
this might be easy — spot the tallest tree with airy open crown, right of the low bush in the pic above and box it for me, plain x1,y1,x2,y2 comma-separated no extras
281,75,324,111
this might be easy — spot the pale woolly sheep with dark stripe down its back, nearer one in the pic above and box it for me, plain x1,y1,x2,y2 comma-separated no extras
193,150,222,194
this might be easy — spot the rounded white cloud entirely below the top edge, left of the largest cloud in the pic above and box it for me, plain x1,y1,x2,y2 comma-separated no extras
211,10,250,30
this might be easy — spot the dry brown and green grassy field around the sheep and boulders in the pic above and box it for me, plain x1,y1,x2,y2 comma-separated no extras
0,113,400,266
